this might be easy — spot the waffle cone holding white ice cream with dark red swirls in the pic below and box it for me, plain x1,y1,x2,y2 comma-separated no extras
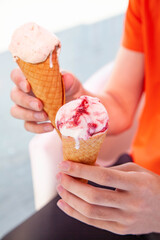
56,96,108,182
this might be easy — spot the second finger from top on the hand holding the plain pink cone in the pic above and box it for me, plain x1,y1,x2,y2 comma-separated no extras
11,87,43,111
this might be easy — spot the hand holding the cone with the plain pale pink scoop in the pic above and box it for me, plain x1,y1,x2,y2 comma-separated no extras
11,68,84,133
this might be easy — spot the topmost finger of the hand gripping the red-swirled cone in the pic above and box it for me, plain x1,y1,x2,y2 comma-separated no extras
59,161,134,190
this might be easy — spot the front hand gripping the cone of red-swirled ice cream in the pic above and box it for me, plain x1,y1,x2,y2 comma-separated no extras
57,161,160,235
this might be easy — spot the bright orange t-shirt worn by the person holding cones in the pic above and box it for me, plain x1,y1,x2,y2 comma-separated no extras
122,0,160,174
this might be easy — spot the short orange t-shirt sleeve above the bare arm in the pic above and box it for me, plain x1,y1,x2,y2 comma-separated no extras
122,0,143,52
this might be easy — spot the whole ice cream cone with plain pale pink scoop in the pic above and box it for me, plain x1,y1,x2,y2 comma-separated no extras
9,23,65,131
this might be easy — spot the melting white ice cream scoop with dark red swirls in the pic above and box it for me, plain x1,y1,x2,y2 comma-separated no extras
56,96,109,148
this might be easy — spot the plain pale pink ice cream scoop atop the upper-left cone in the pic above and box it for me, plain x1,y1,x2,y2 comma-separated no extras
9,23,61,64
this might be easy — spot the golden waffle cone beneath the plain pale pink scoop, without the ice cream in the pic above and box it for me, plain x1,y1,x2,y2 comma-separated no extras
17,49,65,135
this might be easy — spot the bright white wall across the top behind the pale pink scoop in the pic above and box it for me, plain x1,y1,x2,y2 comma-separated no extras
0,0,128,52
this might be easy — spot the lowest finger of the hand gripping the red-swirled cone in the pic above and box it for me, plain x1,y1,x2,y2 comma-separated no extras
57,200,125,234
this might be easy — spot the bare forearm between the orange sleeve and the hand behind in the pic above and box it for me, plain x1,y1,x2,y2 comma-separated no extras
84,47,144,135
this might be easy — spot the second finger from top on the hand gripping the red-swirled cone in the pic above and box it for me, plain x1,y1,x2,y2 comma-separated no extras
56,173,127,208
